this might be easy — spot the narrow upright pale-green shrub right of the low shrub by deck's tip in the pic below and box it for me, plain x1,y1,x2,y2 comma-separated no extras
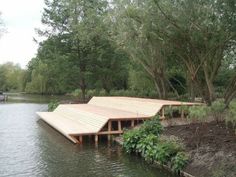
210,99,225,122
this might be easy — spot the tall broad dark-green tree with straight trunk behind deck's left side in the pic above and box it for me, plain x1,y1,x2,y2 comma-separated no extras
22,0,129,99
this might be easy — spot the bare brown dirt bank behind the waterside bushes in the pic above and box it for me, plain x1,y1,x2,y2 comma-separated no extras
164,122,236,177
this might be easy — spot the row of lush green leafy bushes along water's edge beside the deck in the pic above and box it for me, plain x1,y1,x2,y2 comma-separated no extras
123,116,188,172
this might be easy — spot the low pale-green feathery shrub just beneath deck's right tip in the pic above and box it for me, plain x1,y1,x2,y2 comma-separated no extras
188,105,209,122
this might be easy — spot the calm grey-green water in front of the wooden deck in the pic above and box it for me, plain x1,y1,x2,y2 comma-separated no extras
0,96,177,177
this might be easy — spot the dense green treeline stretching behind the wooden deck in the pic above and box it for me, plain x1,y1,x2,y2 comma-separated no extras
15,0,236,104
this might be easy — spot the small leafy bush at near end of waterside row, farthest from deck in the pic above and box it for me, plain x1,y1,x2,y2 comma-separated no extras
171,152,189,173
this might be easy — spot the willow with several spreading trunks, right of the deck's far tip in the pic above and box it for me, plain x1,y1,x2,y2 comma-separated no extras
155,0,235,104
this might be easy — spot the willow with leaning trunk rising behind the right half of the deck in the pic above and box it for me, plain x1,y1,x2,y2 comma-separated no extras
111,0,175,98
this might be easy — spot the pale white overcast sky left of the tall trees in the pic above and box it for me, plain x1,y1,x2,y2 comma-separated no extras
0,0,44,68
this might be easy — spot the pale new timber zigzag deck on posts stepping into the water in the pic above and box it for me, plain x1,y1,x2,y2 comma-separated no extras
37,97,198,143
